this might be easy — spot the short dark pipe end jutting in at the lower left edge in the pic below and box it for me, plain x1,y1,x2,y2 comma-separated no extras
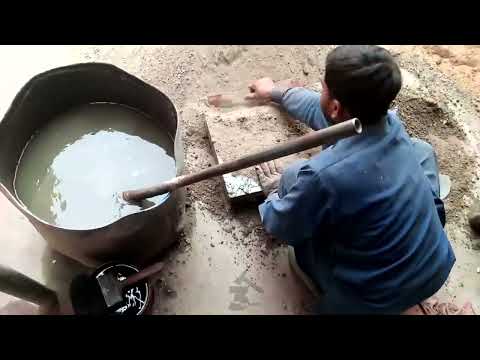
0,265,58,306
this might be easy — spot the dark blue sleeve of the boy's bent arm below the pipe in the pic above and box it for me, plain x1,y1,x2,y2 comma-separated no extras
259,164,334,246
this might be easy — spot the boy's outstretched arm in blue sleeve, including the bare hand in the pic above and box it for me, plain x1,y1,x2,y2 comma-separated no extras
249,78,329,130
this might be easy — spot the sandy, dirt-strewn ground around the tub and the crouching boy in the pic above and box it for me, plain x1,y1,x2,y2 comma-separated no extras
0,46,480,314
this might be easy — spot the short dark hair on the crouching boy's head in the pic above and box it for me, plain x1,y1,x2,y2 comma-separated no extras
325,45,402,124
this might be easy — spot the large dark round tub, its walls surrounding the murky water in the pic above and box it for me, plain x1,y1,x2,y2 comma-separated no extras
0,63,184,266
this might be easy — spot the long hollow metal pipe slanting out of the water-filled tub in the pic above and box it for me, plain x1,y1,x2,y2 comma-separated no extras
123,118,362,201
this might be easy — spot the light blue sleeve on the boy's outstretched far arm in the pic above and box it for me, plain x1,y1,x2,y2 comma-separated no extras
272,88,329,130
